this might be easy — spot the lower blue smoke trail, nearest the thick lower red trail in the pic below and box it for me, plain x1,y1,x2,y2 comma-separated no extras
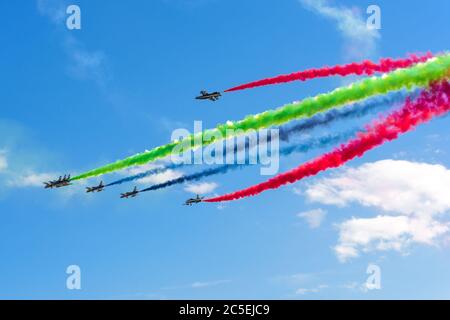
140,129,358,192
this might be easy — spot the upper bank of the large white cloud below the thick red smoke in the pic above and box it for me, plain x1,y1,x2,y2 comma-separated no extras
306,160,450,215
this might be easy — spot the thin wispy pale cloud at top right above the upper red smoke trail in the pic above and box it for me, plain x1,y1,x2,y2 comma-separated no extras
300,0,380,60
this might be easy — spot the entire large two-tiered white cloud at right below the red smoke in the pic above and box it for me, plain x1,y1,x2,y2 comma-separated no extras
305,160,450,261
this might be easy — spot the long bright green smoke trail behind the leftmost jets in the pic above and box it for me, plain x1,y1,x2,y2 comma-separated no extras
71,54,450,180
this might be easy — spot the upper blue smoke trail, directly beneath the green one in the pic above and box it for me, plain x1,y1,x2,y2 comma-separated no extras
106,90,419,187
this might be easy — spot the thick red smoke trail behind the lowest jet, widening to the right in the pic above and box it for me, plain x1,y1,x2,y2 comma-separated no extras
203,81,450,202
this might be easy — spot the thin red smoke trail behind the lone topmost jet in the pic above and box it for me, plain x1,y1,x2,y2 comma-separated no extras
225,52,433,92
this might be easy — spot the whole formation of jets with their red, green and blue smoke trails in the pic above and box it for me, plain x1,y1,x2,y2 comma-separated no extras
44,53,450,206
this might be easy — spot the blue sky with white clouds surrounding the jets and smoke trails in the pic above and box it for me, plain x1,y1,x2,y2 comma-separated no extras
0,0,450,299
